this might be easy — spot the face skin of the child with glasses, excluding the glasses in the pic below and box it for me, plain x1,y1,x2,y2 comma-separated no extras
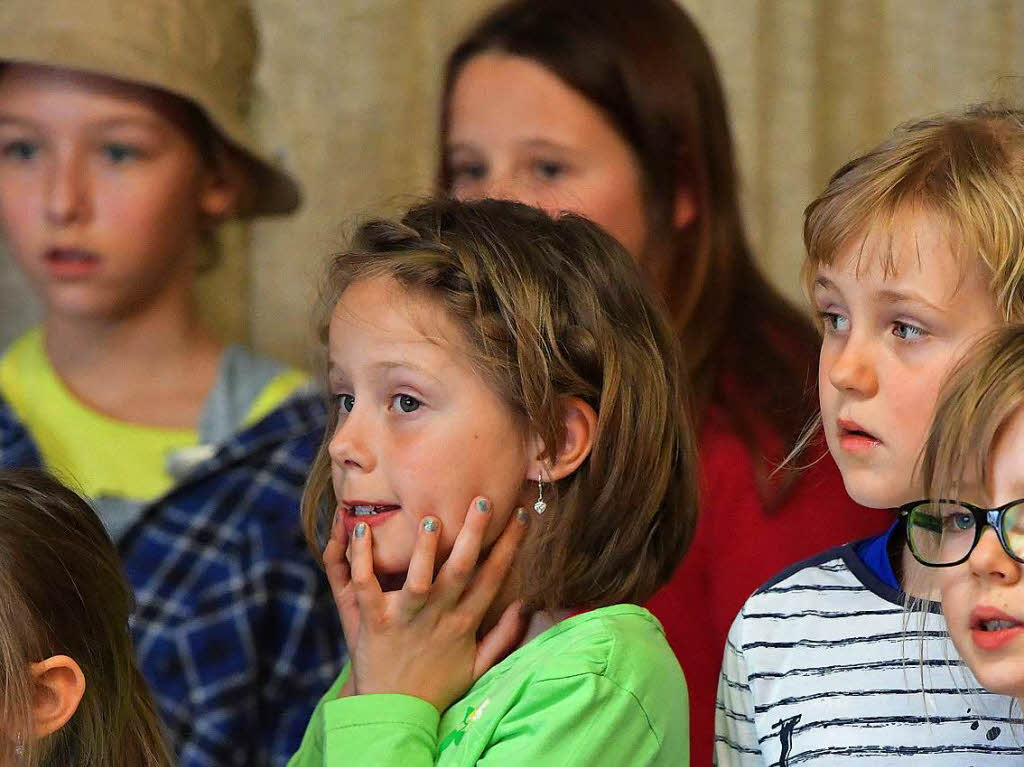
938,411,1024,697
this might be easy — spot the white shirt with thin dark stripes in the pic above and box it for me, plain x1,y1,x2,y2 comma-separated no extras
715,545,1024,767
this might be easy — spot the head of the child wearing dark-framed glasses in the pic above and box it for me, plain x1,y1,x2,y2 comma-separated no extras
917,325,1024,699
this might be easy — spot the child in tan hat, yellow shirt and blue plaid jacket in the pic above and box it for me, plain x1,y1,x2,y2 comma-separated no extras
0,0,342,767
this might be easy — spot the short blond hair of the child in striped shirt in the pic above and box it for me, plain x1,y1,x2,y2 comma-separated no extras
804,103,1024,322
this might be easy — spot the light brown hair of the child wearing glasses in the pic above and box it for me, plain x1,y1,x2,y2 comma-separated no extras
920,325,1024,500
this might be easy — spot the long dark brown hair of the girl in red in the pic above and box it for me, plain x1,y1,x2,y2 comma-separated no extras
438,0,819,501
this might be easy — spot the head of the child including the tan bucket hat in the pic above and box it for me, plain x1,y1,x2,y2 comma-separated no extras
0,0,299,318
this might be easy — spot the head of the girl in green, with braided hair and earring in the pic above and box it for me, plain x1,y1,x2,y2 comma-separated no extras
304,200,695,608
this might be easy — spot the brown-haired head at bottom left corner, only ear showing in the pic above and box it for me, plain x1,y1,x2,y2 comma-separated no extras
0,471,170,767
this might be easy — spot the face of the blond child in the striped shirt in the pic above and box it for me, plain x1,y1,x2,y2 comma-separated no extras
813,211,1001,508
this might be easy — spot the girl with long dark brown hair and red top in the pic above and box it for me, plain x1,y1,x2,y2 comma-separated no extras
439,0,885,753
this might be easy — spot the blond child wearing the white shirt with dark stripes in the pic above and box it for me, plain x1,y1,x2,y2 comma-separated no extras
716,106,1024,767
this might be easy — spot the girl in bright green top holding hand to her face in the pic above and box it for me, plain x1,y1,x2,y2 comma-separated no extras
292,201,695,767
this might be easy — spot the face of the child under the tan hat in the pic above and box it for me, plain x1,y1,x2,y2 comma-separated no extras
0,65,233,319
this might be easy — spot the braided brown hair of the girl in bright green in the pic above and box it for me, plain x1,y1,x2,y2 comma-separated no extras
303,200,696,608
